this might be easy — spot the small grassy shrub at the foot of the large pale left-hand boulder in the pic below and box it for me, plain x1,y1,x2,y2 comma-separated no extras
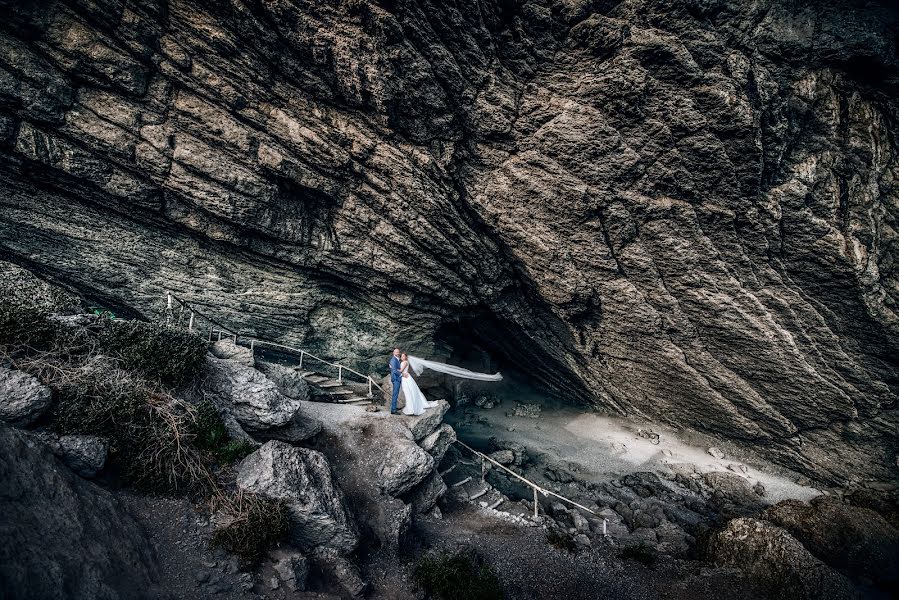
212,491,290,566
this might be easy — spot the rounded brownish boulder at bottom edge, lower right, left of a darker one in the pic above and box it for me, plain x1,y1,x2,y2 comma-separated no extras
708,517,856,600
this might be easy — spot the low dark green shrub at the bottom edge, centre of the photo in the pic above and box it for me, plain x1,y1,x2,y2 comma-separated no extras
414,552,504,600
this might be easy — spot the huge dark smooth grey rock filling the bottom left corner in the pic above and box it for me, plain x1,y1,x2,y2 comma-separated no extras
0,424,161,600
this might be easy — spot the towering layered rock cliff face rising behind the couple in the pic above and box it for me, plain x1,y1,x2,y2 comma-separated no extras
0,0,899,482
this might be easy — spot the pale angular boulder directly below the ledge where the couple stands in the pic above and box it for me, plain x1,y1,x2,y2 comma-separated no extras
378,423,435,497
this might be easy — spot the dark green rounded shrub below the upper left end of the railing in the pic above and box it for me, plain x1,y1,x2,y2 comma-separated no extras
99,320,206,386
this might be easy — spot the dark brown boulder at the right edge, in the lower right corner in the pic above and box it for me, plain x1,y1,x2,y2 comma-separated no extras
763,496,899,583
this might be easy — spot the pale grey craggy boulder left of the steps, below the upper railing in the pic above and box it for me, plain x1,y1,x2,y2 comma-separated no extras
205,357,300,434
